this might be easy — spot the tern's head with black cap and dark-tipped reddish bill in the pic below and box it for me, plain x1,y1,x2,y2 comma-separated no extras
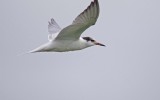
83,37,105,46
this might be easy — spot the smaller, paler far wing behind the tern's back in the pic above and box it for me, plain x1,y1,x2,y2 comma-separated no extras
48,18,62,41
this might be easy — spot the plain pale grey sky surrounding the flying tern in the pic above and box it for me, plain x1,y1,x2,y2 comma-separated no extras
0,0,160,100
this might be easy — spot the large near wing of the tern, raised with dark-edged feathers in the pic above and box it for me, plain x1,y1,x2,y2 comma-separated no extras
55,0,99,40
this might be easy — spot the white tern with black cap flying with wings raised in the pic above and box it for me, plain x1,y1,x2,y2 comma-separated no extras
30,0,105,53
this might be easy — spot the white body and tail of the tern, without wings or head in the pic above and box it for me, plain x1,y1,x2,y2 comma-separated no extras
30,38,90,53
